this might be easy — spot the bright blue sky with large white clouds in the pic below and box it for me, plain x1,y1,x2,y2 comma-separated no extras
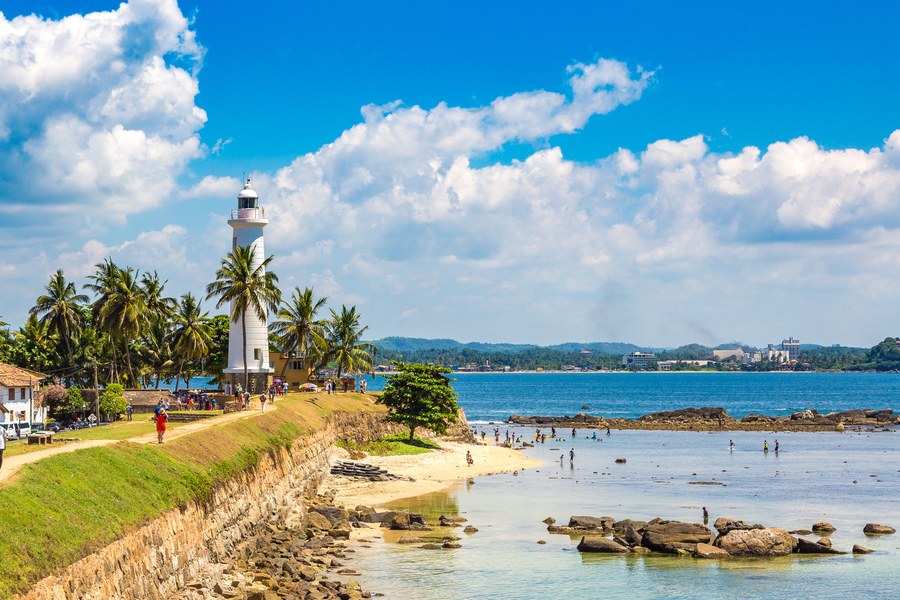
0,0,900,346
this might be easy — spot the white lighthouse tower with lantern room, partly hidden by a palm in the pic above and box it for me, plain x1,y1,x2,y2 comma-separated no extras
223,178,275,394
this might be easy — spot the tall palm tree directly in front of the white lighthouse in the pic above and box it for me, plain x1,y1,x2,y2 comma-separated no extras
206,245,281,389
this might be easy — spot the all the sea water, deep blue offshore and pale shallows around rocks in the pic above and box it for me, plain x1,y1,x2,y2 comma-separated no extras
342,374,900,600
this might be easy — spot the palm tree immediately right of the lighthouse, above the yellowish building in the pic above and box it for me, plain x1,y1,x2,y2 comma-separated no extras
269,287,328,378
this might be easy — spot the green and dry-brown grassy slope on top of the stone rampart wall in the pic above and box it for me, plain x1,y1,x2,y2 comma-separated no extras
0,394,383,598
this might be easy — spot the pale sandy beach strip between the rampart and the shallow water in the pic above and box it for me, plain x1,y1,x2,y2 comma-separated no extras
322,442,542,508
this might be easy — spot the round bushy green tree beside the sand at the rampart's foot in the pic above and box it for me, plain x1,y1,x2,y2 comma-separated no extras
377,361,459,441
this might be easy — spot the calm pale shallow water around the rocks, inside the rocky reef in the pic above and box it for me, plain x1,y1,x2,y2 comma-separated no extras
353,428,900,600
